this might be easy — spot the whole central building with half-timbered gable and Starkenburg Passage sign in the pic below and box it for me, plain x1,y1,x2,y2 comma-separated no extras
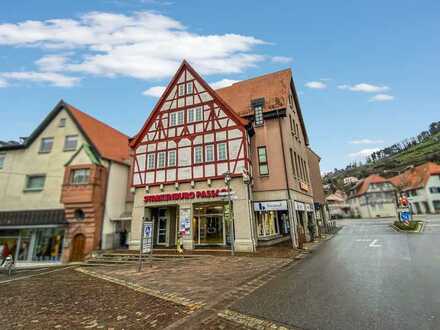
130,61,314,252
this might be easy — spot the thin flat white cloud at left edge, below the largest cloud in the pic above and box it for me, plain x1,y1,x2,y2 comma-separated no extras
0,71,80,87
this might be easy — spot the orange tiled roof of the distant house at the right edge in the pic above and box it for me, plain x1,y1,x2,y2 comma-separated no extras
390,162,440,190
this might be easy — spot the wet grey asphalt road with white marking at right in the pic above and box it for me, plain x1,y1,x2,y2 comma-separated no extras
232,217,440,330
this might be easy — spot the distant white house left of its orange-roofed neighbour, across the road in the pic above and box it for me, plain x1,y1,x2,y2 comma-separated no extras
348,174,396,218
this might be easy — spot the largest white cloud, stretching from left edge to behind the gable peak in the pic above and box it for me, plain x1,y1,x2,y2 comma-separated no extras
0,11,267,80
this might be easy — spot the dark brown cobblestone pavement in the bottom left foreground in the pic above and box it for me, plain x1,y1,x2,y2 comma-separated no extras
0,269,189,330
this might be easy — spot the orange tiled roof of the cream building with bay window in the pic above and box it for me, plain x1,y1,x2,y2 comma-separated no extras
0,100,129,163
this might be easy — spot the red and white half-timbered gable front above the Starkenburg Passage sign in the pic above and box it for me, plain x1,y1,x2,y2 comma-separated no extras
131,61,250,187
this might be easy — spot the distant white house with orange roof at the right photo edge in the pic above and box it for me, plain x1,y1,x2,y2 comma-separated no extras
391,162,440,214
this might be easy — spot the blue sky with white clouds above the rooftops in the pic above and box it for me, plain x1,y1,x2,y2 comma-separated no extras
0,0,440,172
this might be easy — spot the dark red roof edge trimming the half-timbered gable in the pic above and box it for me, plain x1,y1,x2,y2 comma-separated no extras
130,60,248,148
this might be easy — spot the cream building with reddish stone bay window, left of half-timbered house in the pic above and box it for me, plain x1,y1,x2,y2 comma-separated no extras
0,101,129,262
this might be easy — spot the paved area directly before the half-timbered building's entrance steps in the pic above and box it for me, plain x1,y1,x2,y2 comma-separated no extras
88,256,291,305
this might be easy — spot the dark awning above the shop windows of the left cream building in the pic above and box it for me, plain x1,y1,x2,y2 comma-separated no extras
0,209,67,227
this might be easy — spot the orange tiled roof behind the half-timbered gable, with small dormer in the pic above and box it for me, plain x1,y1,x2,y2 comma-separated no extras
216,69,309,145
